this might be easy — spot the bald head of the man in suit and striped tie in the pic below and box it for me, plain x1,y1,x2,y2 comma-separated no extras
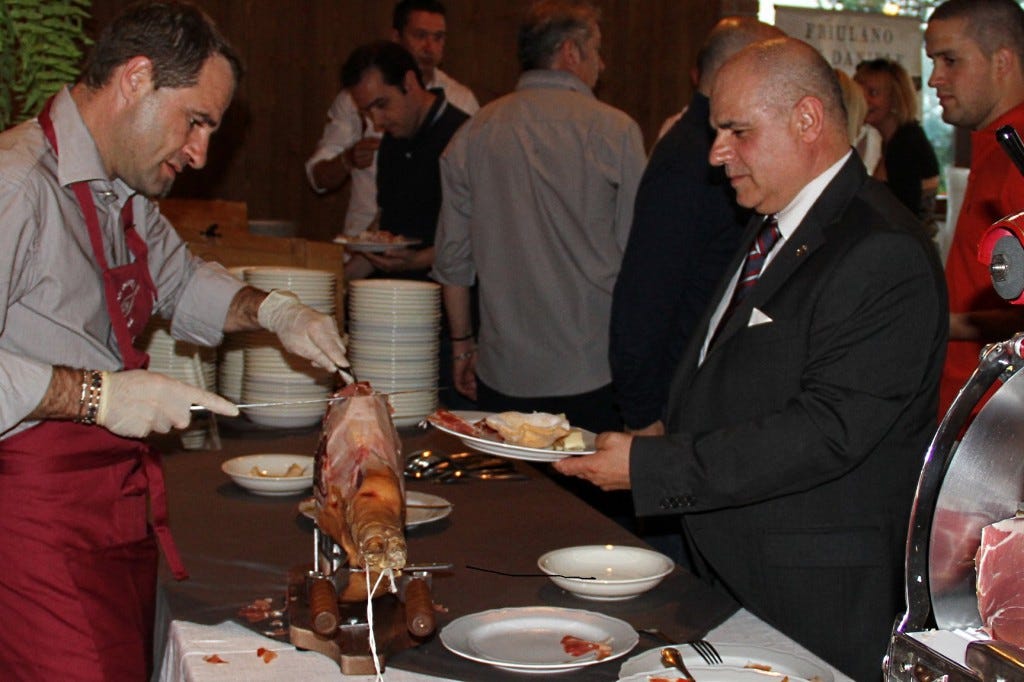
710,38,850,215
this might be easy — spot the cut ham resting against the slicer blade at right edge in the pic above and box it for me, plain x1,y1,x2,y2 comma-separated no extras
975,518,1024,647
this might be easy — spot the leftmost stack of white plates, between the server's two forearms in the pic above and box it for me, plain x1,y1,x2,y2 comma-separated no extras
137,317,217,450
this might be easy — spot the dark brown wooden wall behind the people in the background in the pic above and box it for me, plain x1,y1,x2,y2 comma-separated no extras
90,0,757,240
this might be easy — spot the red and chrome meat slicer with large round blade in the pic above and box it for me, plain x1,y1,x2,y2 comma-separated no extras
883,126,1024,682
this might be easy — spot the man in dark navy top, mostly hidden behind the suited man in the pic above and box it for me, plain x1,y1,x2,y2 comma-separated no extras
609,16,784,435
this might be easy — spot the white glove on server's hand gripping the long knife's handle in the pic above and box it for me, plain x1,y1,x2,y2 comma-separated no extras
96,370,239,438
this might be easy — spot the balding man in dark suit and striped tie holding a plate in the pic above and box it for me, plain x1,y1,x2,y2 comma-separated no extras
556,39,947,680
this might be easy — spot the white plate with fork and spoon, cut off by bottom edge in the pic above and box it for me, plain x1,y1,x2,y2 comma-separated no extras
618,642,836,682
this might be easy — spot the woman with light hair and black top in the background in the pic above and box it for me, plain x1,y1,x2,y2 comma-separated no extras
853,58,939,233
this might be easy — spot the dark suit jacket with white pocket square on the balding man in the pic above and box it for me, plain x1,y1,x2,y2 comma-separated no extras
630,155,948,680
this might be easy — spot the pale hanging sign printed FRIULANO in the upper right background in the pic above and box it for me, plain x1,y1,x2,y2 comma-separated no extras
775,5,923,77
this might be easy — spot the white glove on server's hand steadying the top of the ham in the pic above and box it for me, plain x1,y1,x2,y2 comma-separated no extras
256,290,349,372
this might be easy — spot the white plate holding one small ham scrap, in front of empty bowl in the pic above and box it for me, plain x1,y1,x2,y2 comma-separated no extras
441,606,638,673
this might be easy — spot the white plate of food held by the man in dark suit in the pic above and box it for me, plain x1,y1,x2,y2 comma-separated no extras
426,410,597,462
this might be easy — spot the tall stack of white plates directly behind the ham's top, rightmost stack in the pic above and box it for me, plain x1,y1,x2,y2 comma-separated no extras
348,280,441,426
